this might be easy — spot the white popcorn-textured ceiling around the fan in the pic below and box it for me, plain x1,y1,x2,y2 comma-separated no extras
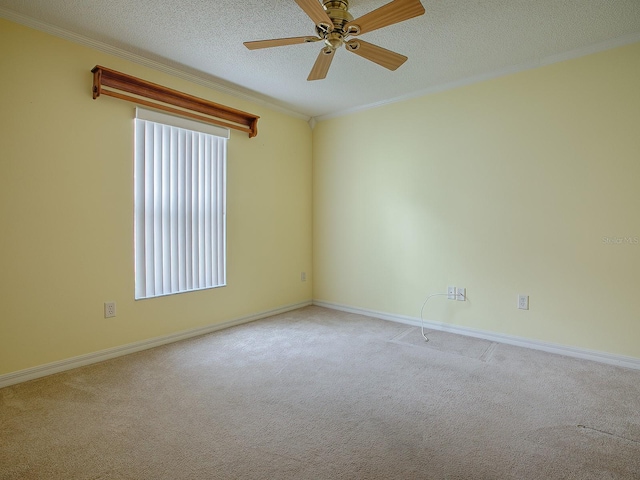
0,0,640,117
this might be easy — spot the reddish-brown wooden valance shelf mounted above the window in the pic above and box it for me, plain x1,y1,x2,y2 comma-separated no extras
91,65,260,137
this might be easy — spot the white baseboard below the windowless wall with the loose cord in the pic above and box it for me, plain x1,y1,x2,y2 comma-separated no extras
313,300,640,370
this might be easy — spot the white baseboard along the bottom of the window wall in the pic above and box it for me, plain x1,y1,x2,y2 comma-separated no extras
0,301,312,388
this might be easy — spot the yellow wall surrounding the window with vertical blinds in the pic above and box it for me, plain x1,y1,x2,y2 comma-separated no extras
0,19,311,374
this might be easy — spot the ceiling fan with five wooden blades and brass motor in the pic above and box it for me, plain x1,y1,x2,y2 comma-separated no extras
244,0,424,80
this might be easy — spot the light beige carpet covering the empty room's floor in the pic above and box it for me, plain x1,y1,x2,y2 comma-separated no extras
0,307,640,480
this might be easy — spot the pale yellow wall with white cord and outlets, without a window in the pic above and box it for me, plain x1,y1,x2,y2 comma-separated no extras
313,44,640,358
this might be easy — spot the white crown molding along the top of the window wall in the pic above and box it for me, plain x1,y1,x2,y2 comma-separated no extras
0,7,310,122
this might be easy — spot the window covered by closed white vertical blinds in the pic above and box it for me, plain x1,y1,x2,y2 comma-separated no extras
134,108,229,299
